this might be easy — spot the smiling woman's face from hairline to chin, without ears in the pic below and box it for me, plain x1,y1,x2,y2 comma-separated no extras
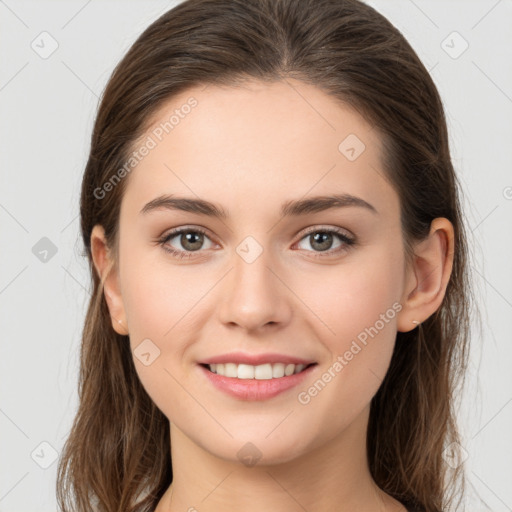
102,80,414,463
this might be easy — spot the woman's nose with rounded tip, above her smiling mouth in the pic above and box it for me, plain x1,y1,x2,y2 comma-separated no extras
218,246,293,332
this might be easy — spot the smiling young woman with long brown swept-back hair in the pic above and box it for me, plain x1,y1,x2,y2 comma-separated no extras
57,0,471,512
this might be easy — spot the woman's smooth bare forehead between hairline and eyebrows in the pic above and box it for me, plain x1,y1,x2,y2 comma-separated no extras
123,80,398,223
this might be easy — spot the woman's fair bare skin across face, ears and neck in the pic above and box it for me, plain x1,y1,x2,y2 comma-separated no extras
91,80,453,512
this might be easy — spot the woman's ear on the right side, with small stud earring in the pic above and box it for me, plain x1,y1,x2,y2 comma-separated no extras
397,217,454,332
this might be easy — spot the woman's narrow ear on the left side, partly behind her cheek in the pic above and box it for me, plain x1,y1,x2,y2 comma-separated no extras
91,224,128,336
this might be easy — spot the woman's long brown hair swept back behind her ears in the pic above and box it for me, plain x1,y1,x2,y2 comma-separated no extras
57,0,473,512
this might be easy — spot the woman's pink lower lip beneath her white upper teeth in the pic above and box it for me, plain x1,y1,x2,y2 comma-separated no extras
199,364,317,400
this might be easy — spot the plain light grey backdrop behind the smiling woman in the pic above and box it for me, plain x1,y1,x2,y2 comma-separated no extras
0,0,512,512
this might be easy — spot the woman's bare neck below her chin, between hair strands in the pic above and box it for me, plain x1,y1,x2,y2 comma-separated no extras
156,408,405,512
